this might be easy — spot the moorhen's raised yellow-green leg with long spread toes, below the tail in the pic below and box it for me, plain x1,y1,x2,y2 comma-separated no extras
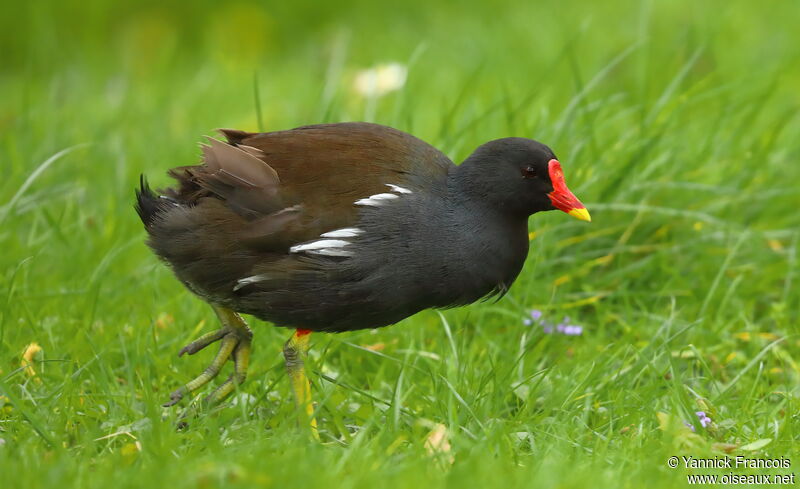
164,306,253,407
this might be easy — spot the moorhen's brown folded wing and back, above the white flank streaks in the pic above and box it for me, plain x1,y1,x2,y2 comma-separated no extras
167,123,452,251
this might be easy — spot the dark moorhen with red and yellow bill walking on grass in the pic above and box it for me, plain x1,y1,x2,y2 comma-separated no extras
136,122,590,433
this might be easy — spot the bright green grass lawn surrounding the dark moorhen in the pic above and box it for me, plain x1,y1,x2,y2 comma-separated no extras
0,1,800,488
